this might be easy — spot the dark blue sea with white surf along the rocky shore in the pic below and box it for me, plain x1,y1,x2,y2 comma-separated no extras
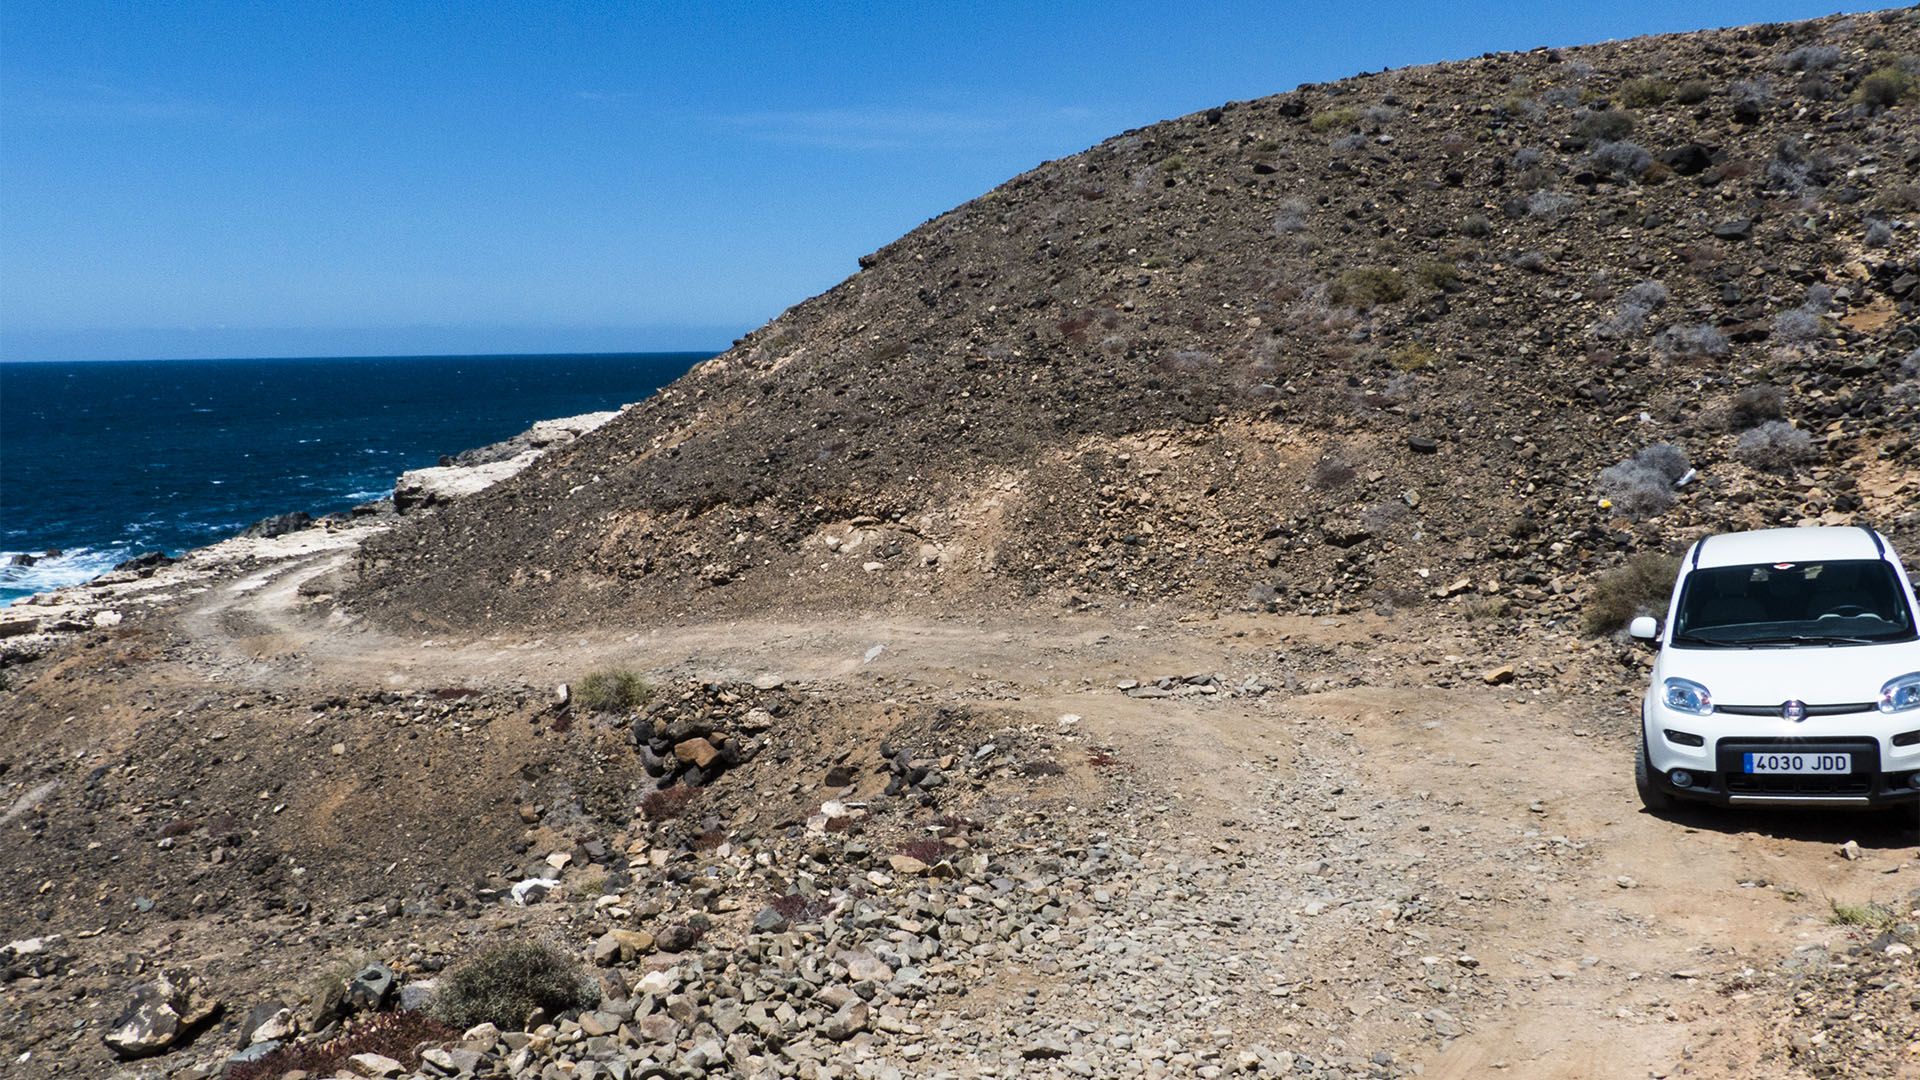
0,354,710,603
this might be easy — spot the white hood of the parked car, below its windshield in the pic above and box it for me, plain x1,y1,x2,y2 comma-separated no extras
1655,630,1920,705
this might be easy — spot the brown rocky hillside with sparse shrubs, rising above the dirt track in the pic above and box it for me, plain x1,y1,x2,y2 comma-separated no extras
351,10,1920,626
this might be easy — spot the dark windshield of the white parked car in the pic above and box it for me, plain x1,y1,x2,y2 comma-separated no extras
1674,559,1914,648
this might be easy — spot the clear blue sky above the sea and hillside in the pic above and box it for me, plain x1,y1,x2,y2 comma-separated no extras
0,0,1881,359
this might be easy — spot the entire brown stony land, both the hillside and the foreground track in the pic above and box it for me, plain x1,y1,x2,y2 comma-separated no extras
11,10,1920,1080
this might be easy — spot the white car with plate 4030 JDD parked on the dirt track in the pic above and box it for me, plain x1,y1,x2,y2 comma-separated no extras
1628,527,1920,811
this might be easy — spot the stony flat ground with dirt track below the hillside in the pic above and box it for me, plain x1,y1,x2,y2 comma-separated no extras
0,530,1920,1078
